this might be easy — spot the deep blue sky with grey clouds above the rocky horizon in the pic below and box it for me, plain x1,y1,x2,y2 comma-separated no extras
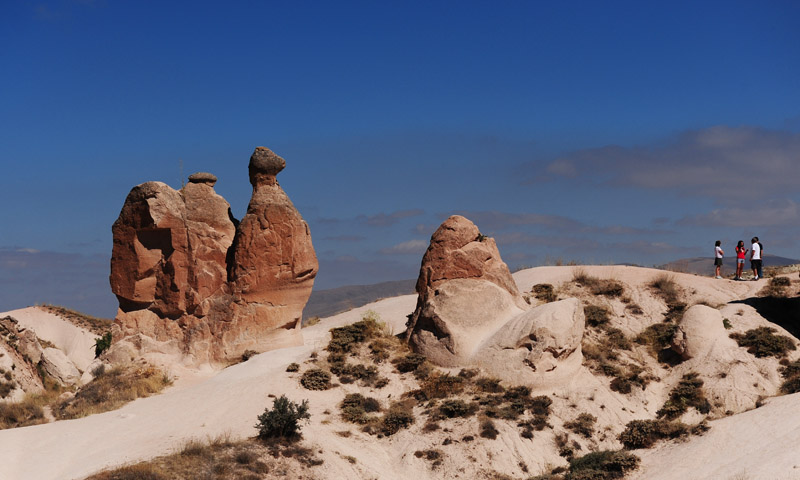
0,0,800,316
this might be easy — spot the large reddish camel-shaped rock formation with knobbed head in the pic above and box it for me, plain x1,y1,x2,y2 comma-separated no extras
110,147,318,362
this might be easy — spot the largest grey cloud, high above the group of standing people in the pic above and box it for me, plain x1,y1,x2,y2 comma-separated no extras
536,126,800,204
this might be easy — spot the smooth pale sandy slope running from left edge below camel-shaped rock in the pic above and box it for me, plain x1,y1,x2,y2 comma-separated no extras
0,295,416,480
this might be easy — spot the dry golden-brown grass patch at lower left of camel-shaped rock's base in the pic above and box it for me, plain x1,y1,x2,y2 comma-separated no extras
53,365,172,420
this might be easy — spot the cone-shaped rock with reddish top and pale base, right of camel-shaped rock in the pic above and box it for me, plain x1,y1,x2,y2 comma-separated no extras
407,215,527,366
